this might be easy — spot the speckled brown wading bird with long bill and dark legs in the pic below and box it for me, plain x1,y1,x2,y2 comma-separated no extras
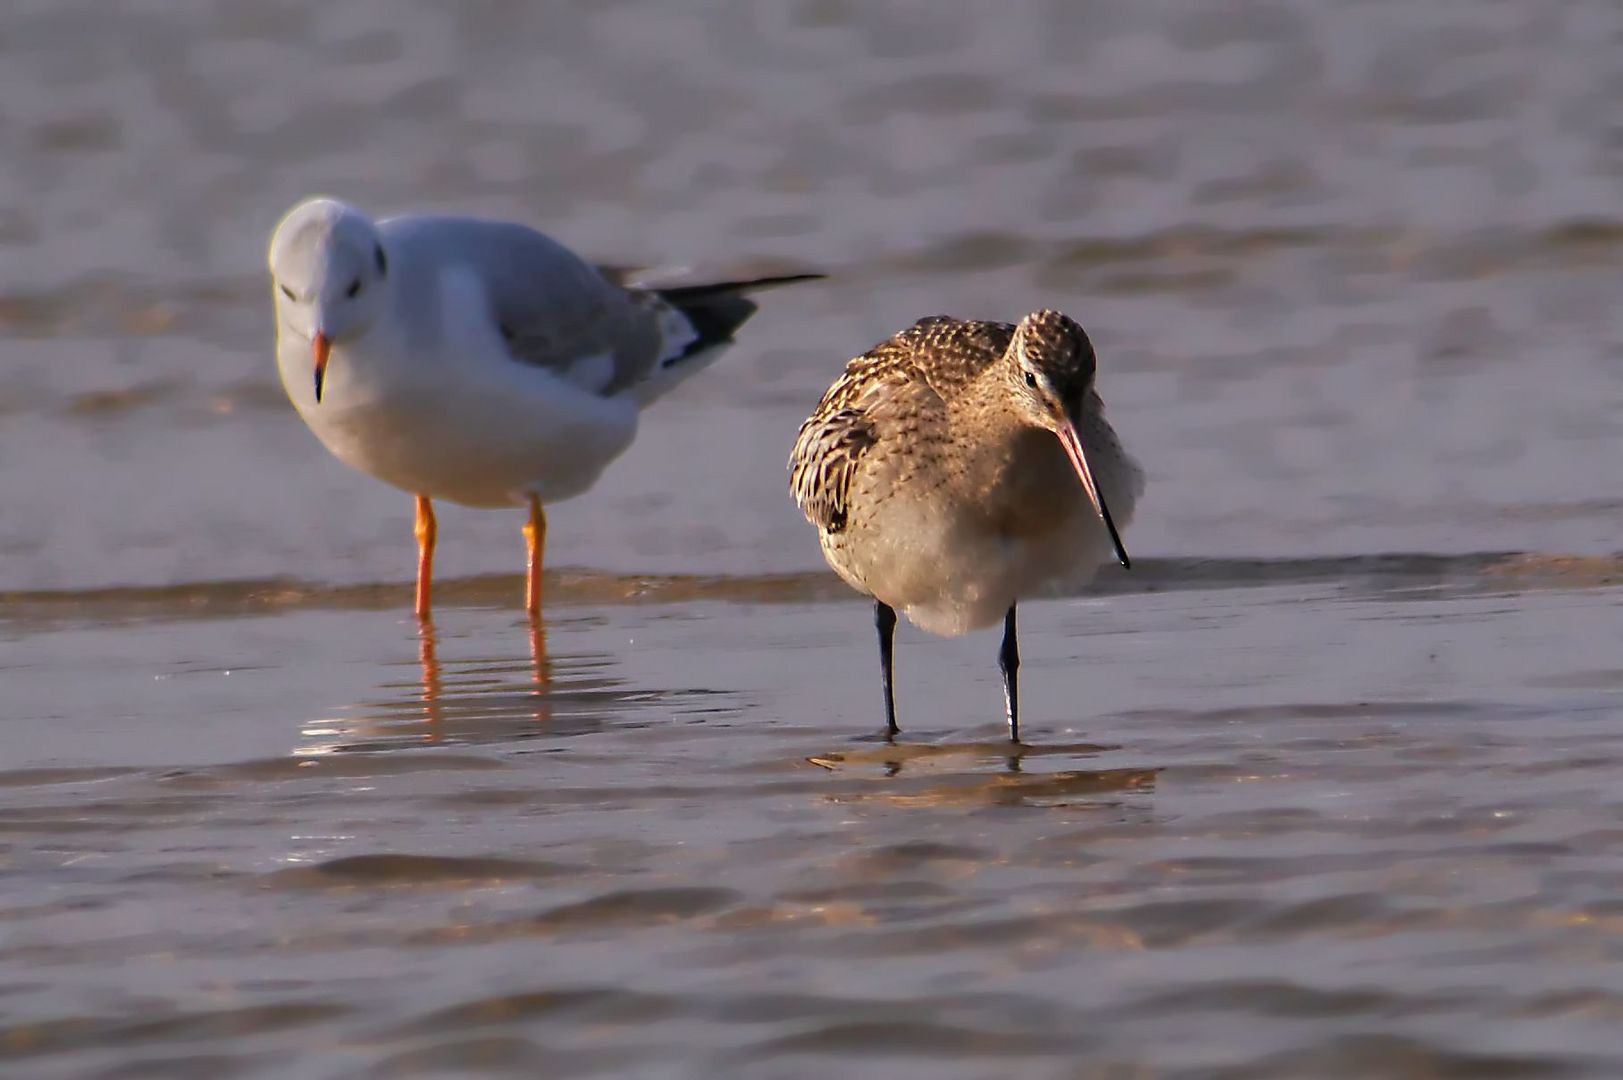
789,309,1144,742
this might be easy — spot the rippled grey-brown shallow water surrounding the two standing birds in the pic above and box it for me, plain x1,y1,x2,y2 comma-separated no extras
0,0,1623,1078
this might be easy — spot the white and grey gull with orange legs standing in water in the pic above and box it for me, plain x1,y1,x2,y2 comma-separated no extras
269,198,821,619
